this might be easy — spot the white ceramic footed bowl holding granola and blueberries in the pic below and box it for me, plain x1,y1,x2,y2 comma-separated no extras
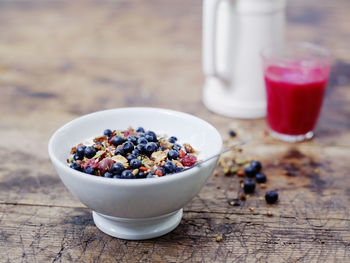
48,108,222,240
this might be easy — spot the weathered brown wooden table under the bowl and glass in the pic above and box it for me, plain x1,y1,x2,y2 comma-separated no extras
0,0,350,262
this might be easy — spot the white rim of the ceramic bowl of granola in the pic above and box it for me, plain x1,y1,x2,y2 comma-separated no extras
48,107,223,186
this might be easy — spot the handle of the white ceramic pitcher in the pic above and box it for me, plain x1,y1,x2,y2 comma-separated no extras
202,0,221,77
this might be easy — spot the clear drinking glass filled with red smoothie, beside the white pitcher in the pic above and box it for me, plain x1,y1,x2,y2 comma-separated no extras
261,42,331,142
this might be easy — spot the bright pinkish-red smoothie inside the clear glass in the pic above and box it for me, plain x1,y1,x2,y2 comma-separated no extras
265,62,329,135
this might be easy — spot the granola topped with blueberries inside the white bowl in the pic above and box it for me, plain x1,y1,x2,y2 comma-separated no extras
67,127,198,179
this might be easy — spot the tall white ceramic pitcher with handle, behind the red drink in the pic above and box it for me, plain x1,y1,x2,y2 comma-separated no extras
203,0,286,118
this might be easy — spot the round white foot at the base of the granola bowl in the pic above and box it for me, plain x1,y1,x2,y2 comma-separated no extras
92,209,183,240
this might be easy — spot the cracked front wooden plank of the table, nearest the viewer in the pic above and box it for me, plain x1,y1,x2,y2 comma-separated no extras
0,205,350,262
